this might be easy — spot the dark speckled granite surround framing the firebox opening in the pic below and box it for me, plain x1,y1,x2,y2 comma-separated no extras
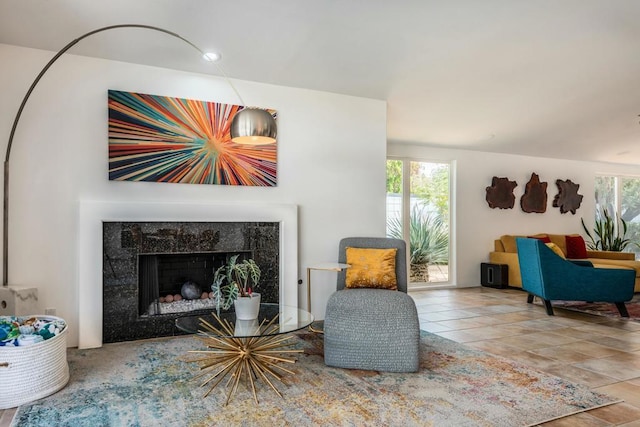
102,222,280,343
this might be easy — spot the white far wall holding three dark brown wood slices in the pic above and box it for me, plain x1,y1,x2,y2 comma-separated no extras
388,143,640,287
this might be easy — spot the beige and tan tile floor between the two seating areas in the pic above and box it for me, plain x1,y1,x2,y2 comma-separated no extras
0,288,640,427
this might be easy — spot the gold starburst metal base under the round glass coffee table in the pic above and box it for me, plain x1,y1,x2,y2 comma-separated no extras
186,313,304,406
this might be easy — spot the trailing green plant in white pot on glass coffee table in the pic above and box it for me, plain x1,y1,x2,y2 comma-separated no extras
211,255,260,320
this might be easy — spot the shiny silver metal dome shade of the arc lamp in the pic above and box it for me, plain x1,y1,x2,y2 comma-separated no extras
231,108,278,145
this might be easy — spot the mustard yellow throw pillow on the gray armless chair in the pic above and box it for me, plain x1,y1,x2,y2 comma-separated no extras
345,247,398,290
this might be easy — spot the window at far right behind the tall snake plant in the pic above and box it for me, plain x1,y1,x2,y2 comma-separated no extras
589,176,640,258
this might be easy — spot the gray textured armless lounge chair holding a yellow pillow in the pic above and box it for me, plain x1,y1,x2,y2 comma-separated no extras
324,237,420,372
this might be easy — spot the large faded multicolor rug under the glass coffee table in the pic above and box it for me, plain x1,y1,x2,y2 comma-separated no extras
11,332,617,427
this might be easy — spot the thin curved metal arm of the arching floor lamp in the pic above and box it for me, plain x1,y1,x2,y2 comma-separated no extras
2,24,212,287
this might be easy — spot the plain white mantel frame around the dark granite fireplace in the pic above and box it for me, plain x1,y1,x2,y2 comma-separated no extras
78,200,298,348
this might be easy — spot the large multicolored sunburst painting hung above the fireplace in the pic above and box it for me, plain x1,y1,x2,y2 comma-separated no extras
109,90,277,187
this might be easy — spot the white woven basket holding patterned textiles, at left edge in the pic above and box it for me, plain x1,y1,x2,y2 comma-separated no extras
0,315,69,409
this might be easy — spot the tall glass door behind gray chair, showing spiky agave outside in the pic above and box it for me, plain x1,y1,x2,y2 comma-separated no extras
387,159,451,286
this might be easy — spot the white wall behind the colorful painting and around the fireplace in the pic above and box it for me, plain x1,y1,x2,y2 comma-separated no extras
0,44,386,345
